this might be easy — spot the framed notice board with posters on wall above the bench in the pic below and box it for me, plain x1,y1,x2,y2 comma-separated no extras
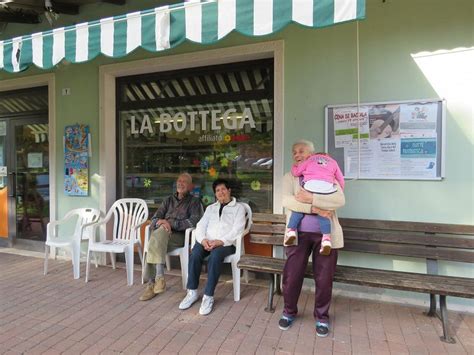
325,99,446,180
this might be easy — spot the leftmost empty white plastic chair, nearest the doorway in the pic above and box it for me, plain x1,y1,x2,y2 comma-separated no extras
44,208,100,279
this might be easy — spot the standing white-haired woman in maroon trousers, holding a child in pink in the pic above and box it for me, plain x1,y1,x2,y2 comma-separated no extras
278,140,345,337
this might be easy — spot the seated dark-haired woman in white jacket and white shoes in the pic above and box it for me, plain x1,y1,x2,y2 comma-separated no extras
179,179,245,315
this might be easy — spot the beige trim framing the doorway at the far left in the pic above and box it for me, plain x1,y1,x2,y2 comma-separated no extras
0,73,58,248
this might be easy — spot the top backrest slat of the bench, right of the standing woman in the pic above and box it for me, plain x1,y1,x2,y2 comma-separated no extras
339,218,474,235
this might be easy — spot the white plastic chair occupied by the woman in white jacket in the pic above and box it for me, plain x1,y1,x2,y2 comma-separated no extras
191,202,252,302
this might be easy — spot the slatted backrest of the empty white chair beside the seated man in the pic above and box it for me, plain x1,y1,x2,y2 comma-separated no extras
109,198,148,240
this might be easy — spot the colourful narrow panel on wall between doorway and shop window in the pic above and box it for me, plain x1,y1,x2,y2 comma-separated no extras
64,124,90,196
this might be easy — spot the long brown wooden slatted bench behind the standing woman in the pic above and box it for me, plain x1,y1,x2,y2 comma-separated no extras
238,213,474,343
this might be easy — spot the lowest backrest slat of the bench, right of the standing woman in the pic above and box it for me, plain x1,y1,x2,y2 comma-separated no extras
341,240,474,263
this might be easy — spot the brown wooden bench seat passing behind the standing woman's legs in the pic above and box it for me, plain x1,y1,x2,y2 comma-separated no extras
238,255,474,298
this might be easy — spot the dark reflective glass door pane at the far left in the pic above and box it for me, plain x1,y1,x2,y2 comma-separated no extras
8,118,49,241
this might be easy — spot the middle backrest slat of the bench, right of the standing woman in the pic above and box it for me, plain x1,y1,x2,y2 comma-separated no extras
343,228,474,249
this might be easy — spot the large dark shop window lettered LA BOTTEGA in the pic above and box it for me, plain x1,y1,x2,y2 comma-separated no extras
117,59,274,212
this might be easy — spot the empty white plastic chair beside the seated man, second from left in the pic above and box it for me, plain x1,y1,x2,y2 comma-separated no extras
86,198,148,286
